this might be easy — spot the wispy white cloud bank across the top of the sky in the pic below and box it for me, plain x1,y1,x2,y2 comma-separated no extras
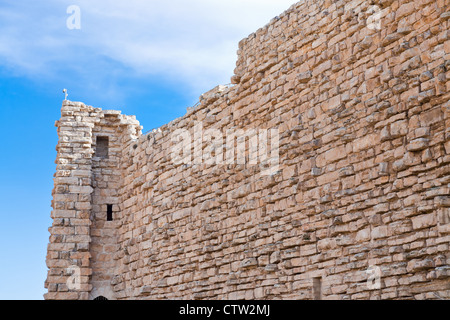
0,0,296,94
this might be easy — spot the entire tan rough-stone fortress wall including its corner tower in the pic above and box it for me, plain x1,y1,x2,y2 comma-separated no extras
45,0,450,299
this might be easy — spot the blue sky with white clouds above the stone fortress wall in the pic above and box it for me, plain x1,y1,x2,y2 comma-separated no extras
0,0,296,299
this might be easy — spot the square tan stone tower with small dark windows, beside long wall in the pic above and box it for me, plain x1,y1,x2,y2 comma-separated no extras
45,100,141,299
